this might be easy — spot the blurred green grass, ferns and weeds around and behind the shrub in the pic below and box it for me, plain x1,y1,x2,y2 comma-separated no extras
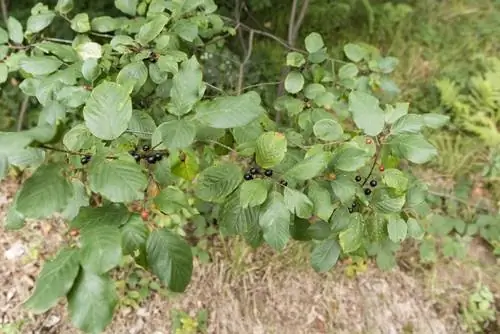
0,0,500,333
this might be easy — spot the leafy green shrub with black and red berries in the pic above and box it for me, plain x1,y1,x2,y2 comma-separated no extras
0,0,447,333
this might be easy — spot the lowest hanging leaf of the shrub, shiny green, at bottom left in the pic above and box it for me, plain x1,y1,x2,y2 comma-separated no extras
68,270,118,333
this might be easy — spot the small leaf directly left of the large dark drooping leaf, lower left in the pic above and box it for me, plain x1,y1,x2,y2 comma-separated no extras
120,214,149,260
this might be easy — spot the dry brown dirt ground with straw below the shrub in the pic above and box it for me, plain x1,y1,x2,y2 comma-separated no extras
0,182,500,334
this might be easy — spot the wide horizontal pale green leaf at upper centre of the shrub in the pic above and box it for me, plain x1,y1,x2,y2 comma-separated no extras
196,91,266,129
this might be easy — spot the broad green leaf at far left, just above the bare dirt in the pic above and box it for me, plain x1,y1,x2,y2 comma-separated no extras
16,164,72,218
